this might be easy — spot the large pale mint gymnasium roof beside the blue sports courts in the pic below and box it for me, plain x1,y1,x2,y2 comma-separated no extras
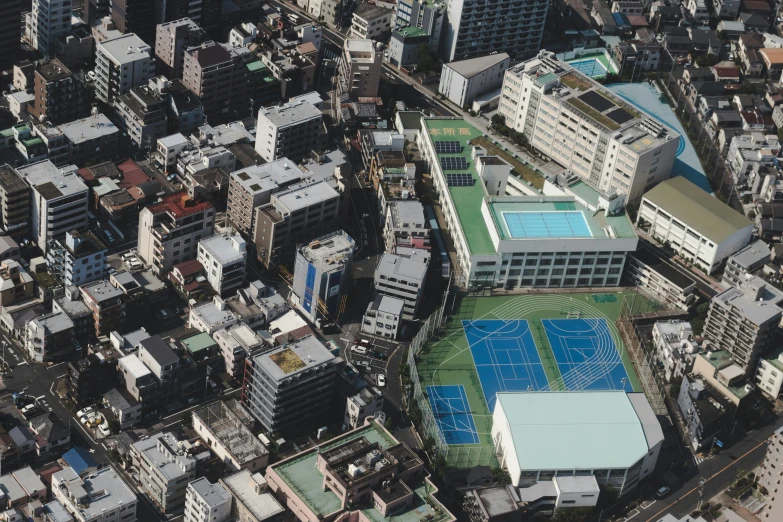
493,391,663,470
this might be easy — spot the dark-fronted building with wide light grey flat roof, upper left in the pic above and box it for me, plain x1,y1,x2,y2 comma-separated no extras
57,113,120,165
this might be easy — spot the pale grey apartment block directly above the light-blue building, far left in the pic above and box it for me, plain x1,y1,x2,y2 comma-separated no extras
17,160,89,253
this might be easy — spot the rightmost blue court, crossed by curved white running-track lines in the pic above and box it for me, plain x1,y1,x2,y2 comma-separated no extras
541,319,633,392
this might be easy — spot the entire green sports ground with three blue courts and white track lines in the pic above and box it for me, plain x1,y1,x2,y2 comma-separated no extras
416,291,655,467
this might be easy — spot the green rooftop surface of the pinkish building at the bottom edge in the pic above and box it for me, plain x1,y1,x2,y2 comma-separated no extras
273,422,449,522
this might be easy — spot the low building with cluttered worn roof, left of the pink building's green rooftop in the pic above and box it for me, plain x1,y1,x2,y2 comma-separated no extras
193,399,269,473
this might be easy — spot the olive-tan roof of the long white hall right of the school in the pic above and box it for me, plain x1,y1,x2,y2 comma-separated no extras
644,176,753,244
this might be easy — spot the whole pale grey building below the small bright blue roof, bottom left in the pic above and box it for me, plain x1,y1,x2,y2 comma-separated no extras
52,466,139,522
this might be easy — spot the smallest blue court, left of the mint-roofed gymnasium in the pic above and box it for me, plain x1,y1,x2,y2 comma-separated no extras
426,384,479,444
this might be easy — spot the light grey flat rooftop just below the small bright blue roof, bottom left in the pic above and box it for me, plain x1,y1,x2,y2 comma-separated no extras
52,466,137,520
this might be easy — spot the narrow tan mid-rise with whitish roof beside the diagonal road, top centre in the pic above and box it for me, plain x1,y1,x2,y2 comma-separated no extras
338,38,383,100
